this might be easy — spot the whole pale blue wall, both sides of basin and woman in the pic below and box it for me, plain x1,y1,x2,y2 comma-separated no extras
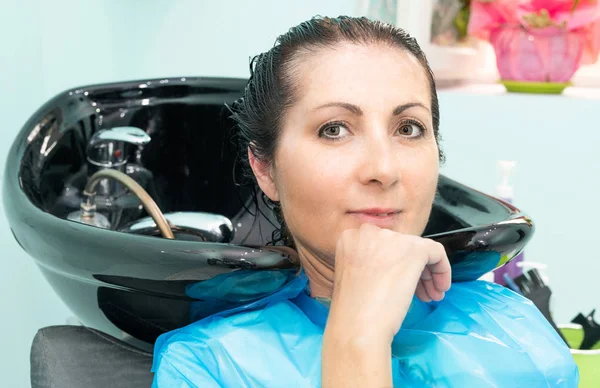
0,0,600,387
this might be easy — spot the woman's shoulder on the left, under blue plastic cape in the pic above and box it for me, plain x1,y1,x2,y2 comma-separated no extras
153,300,323,386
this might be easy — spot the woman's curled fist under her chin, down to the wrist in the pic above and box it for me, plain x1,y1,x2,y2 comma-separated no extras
330,224,451,343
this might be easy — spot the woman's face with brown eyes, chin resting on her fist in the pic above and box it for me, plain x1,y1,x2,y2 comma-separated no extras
253,43,438,264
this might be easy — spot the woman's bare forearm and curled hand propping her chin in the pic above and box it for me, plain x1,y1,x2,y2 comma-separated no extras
322,224,451,386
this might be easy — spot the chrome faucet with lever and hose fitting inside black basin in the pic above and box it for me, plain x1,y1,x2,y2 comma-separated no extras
86,127,151,196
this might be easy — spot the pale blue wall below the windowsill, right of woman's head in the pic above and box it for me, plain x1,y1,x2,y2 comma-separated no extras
440,89,600,323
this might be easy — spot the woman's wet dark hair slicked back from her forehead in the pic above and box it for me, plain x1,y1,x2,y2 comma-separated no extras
229,16,444,247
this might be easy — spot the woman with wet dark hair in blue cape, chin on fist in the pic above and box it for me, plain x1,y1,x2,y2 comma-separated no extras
153,17,577,387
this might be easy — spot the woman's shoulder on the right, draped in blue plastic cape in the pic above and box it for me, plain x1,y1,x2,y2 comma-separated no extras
392,281,579,387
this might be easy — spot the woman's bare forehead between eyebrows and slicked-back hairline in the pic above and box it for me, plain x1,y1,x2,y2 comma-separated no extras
297,43,430,111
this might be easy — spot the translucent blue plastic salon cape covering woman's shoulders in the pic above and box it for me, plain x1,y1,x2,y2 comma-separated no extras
152,271,579,388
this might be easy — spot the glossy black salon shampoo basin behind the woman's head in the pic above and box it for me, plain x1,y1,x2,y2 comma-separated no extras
3,78,533,348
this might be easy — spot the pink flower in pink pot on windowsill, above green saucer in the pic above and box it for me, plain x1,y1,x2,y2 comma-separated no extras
468,0,600,88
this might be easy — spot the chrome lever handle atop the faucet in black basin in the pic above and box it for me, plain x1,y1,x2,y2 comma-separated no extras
87,127,151,169
